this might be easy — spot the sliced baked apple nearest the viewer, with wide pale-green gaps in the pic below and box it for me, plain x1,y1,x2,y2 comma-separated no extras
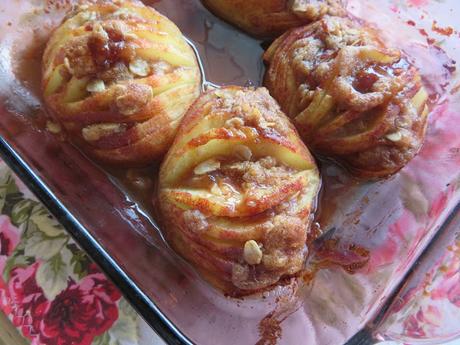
159,86,320,295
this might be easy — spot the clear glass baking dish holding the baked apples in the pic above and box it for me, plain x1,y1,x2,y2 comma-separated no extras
0,0,460,345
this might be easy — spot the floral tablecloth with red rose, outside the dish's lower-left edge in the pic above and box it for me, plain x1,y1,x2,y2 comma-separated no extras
0,161,159,345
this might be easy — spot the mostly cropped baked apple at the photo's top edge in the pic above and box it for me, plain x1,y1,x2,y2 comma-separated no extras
202,0,345,37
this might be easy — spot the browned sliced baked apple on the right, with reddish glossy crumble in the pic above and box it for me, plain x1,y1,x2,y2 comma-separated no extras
265,17,428,178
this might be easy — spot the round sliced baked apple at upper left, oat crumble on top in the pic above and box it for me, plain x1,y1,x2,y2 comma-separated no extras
42,1,201,165
